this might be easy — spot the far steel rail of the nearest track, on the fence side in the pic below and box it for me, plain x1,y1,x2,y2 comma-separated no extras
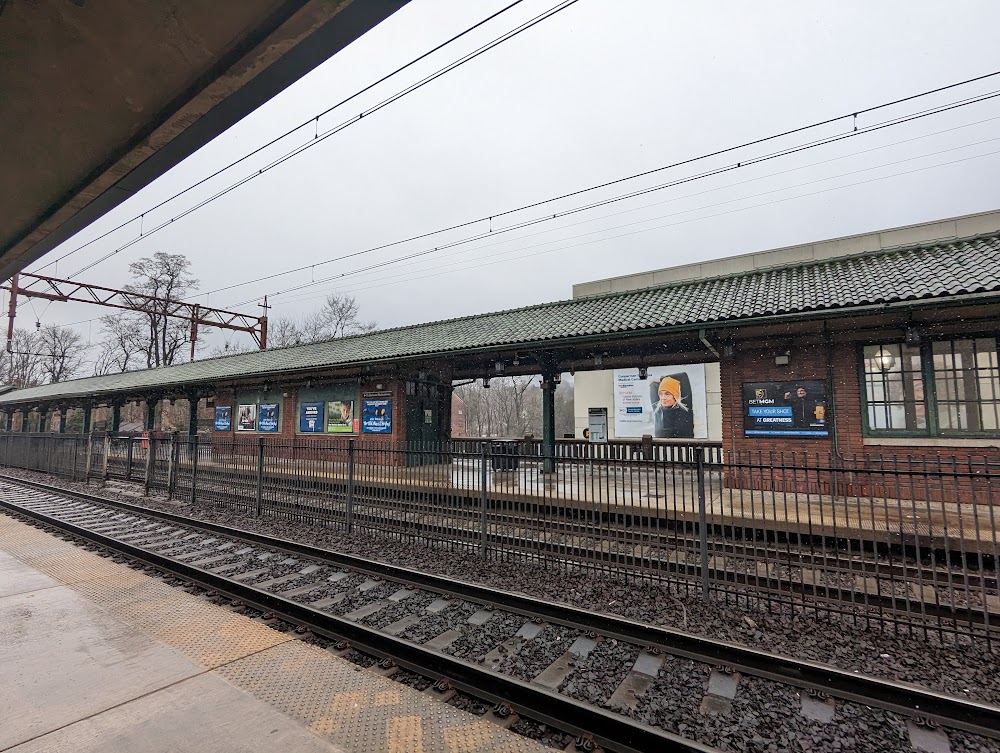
0,474,1000,739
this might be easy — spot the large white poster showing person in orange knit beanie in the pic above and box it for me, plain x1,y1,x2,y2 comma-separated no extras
614,363,708,439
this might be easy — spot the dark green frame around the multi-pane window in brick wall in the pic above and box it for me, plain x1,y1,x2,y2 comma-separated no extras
856,332,1000,439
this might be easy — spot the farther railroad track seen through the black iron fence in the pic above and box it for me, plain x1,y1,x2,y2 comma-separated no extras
137,470,1000,635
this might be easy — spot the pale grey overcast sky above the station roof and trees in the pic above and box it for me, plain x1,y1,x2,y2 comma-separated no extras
18,0,1000,358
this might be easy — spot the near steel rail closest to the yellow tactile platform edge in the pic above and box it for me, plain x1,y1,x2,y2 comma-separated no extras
0,482,720,753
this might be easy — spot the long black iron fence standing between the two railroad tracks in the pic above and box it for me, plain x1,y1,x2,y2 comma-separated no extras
0,433,1000,641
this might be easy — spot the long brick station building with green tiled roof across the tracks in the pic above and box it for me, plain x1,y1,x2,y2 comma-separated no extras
0,212,1000,492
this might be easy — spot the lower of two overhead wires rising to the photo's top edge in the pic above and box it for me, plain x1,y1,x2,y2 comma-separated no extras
45,0,579,277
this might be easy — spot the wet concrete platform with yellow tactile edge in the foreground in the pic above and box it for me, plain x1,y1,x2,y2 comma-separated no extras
0,515,544,753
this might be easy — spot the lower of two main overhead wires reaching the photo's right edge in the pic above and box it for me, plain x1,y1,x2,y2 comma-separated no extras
223,91,1000,305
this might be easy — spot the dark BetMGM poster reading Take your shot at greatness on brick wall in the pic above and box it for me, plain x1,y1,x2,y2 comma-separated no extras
743,381,830,437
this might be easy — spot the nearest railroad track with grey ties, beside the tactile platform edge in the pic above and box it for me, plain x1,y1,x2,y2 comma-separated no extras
0,477,1000,751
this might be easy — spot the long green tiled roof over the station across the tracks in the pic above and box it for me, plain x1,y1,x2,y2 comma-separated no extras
0,235,1000,405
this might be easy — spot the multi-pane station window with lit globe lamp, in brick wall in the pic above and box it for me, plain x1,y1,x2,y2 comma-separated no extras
861,337,1000,437
